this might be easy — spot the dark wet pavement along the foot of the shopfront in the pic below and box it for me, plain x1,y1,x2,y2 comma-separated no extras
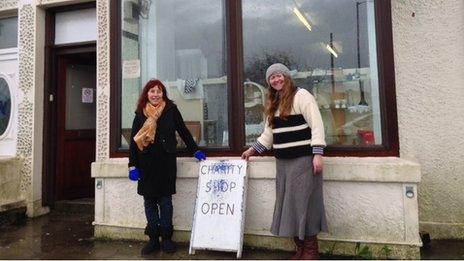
0,213,464,260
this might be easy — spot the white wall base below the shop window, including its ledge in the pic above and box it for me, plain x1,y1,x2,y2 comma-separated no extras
92,157,421,258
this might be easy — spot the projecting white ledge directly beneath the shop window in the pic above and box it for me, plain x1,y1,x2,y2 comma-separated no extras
92,156,421,183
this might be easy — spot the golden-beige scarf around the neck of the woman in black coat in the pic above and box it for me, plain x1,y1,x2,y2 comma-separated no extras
134,100,166,151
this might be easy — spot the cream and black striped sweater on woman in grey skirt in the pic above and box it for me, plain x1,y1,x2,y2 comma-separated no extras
252,88,326,158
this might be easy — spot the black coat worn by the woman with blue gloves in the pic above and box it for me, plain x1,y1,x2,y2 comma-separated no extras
129,101,198,197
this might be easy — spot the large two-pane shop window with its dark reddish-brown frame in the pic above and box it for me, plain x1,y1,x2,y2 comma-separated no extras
111,0,399,156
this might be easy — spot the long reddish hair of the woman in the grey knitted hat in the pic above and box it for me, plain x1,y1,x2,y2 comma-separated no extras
266,75,296,127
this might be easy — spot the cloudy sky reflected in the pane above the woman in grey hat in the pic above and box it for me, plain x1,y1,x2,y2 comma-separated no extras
243,0,374,70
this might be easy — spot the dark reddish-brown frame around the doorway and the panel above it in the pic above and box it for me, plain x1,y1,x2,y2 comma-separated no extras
42,2,97,205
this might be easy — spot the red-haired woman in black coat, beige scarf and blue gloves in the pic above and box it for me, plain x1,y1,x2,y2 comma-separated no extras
129,79,206,255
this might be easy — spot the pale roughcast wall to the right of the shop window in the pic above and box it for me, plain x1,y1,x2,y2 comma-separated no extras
392,0,464,238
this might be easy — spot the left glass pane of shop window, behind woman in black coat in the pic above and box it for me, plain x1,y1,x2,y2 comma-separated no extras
121,0,229,148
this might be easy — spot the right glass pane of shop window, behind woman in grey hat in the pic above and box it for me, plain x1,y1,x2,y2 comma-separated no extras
242,0,382,146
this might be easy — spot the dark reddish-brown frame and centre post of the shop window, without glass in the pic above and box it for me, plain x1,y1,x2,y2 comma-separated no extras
110,0,399,157
